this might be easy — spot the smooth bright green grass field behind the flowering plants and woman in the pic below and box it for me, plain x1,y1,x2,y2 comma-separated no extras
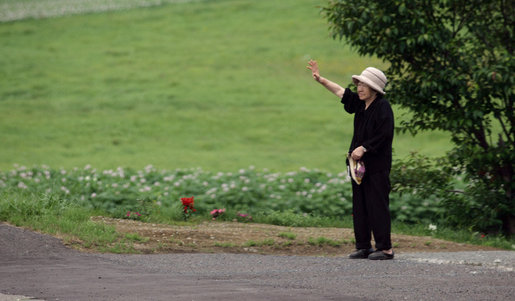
0,0,451,171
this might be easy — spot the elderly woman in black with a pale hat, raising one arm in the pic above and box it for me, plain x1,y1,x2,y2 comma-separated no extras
307,60,394,260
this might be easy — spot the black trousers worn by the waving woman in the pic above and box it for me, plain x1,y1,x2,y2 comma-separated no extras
352,172,392,250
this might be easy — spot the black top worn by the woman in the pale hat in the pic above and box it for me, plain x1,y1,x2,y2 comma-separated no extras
342,89,394,174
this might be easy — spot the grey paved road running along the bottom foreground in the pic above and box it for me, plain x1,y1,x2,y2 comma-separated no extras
0,224,515,301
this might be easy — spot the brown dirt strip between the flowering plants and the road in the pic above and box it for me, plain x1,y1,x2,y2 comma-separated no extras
77,217,504,256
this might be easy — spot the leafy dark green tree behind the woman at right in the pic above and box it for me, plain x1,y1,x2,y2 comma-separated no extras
322,0,515,234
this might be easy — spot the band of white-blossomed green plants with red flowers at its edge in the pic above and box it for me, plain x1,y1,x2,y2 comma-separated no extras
0,165,444,221
